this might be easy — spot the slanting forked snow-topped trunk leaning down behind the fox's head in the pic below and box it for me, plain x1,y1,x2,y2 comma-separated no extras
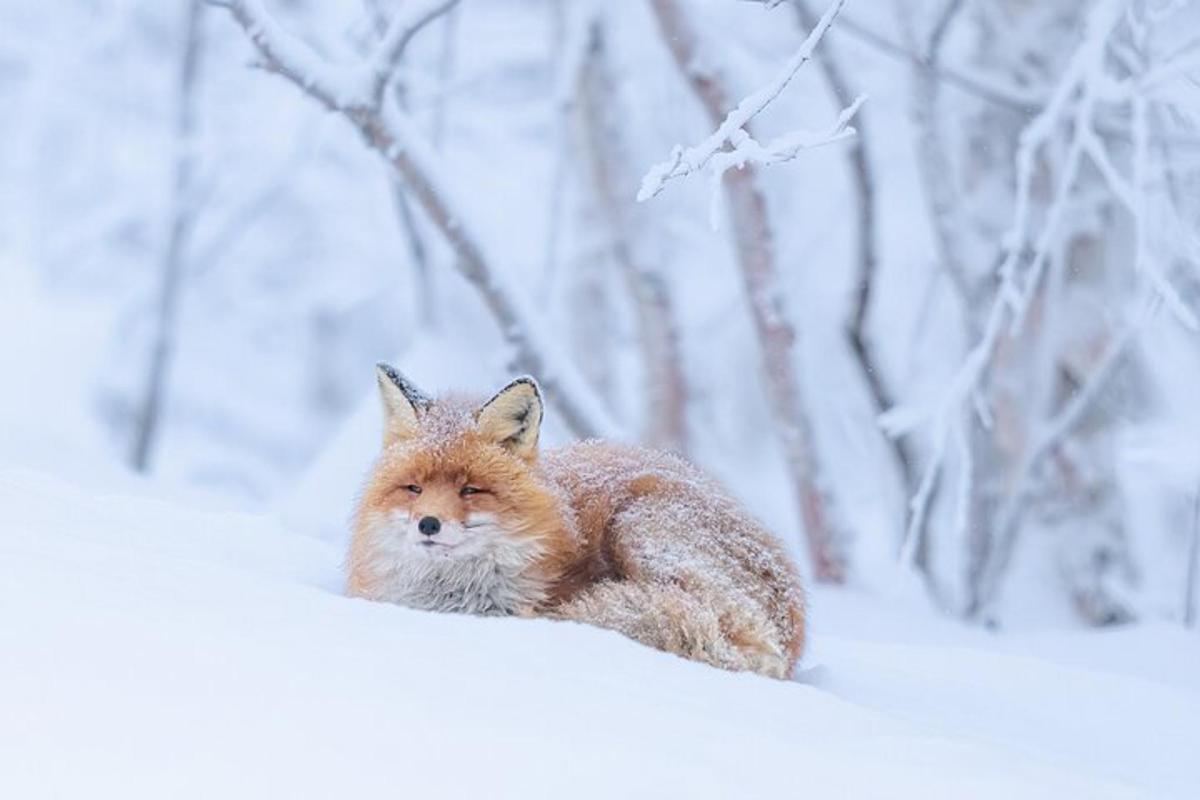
209,0,622,438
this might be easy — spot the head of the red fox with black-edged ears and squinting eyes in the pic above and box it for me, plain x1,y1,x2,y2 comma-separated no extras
352,365,564,610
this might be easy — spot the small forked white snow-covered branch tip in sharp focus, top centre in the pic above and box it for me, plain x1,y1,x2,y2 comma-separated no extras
637,0,865,212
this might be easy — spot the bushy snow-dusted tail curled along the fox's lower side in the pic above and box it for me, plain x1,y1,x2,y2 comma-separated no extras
550,581,793,679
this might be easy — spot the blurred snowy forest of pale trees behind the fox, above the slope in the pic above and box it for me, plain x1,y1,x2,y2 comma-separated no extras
0,0,1200,626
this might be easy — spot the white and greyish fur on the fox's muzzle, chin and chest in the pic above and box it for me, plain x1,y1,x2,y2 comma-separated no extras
362,515,546,614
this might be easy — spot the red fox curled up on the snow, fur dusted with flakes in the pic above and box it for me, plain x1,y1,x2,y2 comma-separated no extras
348,365,804,678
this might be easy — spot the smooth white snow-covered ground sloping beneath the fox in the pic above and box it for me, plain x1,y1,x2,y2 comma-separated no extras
0,469,1200,799
